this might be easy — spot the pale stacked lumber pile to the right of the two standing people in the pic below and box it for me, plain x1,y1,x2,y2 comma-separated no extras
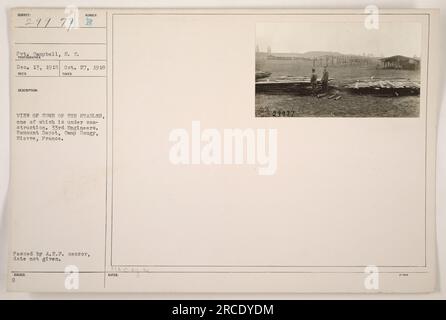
345,79,420,97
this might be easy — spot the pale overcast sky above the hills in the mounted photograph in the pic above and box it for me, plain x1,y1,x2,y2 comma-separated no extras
256,22,421,57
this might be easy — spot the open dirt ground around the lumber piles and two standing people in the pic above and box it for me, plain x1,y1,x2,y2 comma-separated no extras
255,60,420,117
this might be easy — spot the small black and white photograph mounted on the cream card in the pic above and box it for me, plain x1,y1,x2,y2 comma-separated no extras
255,22,421,118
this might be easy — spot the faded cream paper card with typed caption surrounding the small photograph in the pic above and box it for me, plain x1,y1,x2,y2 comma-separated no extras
8,8,437,292
